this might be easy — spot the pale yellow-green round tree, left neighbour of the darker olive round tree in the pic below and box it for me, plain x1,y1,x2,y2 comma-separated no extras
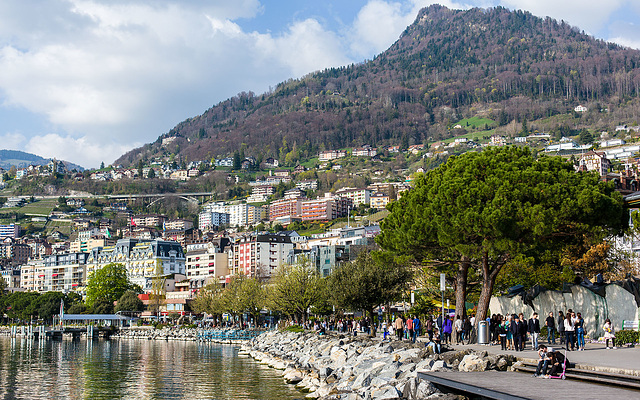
268,258,327,322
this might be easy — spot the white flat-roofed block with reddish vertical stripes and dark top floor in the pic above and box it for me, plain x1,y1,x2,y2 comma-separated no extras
228,234,294,279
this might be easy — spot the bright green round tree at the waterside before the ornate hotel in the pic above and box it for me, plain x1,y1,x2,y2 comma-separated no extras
86,263,139,308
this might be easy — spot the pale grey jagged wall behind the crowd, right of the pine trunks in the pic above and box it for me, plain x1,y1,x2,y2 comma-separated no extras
489,284,640,339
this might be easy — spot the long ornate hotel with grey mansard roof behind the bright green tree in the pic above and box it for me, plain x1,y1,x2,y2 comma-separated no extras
87,239,185,292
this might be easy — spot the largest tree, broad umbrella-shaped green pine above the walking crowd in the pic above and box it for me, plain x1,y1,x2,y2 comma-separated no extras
377,147,627,319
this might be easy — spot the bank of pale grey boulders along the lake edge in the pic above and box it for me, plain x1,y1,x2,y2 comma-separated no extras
241,331,515,400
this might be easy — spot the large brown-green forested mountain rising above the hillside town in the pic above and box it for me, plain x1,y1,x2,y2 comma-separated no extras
115,5,640,165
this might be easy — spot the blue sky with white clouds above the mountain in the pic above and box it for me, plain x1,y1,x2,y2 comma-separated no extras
0,0,640,168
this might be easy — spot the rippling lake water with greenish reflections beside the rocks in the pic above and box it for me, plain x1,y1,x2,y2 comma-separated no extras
0,336,304,400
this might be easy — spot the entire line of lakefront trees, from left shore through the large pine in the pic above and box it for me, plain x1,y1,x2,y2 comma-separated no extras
2,147,628,330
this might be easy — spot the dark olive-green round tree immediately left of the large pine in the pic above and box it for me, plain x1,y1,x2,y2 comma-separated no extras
329,251,411,332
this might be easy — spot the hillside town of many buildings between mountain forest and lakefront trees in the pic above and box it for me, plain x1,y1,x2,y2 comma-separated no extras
0,130,640,317
